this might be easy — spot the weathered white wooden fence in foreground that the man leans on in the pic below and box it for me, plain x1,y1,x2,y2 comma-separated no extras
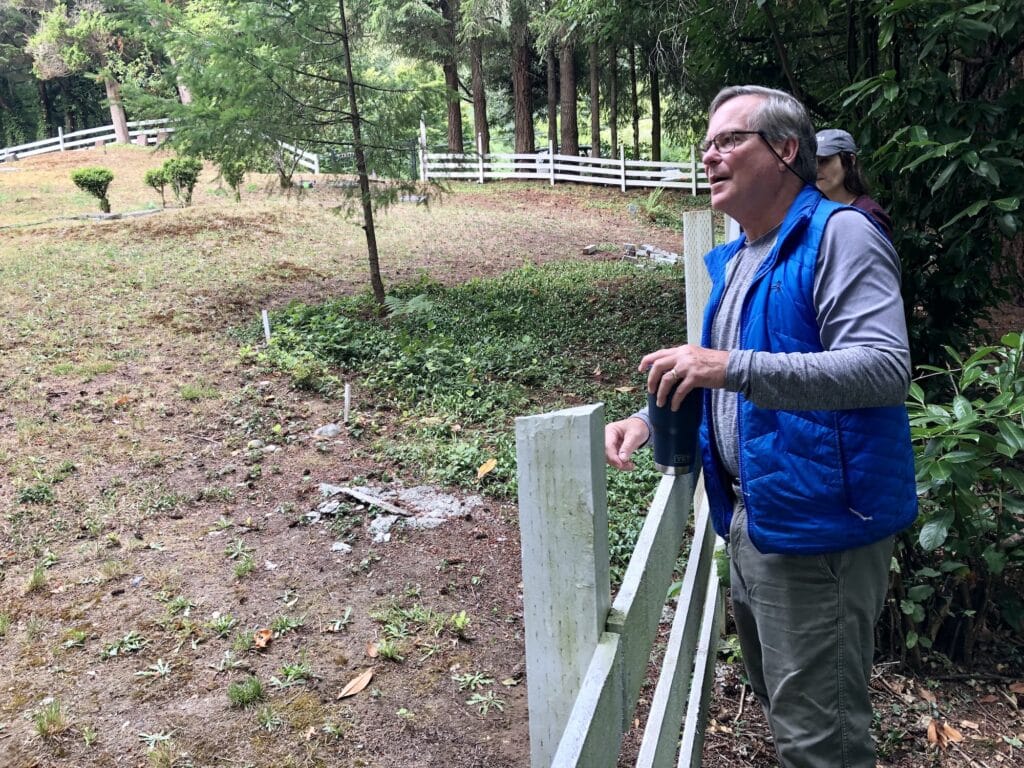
516,211,723,768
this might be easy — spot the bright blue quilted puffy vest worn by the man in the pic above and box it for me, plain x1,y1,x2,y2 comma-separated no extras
700,186,918,555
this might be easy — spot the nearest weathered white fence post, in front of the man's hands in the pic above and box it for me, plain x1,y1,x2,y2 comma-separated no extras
516,403,611,768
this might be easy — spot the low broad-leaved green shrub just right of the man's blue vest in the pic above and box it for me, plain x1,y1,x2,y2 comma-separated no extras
889,333,1024,664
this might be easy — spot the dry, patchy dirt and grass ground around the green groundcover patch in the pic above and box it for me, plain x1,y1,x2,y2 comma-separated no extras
0,151,1024,768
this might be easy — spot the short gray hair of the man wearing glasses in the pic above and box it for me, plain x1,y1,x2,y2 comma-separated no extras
708,85,818,184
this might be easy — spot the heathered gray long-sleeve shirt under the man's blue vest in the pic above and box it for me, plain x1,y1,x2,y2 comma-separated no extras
636,211,910,477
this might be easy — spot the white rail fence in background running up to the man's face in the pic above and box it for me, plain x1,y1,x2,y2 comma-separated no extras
419,124,711,195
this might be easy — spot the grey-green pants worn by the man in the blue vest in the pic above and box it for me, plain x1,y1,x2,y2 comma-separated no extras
729,504,893,768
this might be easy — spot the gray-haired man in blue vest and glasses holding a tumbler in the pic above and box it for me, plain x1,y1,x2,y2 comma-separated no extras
605,81,918,768
